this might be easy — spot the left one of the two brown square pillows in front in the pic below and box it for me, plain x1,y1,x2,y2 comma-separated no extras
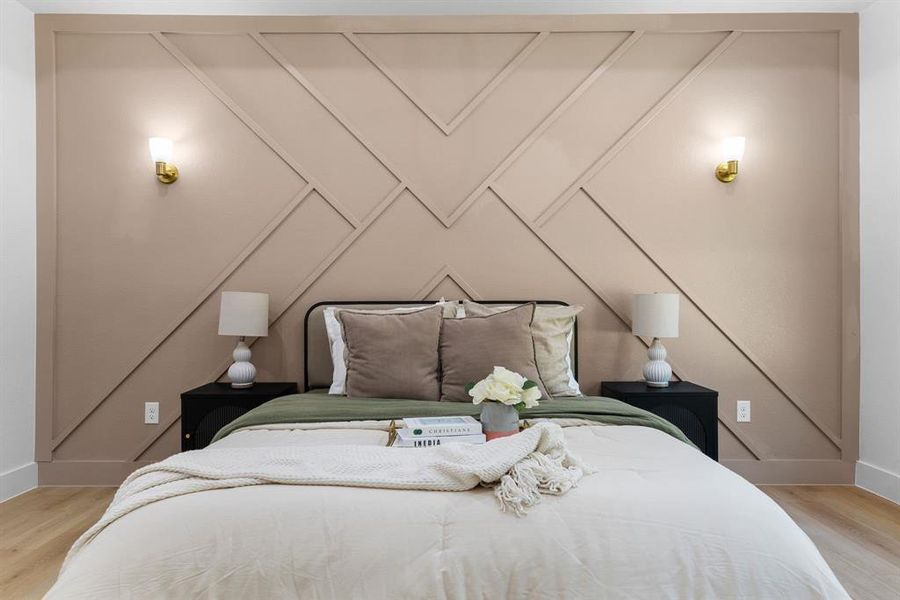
338,306,443,400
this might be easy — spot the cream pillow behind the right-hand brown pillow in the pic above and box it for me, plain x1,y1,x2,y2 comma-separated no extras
463,300,584,396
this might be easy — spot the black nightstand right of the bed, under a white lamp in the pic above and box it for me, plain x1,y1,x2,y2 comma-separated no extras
600,381,719,461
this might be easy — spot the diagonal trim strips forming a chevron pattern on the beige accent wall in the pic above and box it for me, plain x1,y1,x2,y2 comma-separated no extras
45,31,841,468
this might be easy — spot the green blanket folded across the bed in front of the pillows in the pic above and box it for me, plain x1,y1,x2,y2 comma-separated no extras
213,393,693,445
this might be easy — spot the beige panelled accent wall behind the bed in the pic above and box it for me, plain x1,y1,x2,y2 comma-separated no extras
37,14,858,484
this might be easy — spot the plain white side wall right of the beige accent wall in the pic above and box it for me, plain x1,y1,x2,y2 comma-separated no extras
856,0,900,503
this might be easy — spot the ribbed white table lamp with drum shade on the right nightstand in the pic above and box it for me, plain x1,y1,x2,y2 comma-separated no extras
631,294,679,387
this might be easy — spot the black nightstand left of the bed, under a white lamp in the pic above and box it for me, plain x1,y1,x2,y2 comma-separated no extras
181,381,297,452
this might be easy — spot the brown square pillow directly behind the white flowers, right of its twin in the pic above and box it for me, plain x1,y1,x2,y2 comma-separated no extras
440,303,548,402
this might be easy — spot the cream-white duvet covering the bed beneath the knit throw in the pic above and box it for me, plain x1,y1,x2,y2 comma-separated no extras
48,423,848,600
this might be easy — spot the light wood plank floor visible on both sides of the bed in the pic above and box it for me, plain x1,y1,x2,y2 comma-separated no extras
0,486,900,600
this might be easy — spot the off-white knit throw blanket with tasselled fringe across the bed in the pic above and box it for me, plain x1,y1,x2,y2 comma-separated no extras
63,423,590,569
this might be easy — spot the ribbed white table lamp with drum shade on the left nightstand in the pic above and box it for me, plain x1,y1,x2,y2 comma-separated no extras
219,292,269,388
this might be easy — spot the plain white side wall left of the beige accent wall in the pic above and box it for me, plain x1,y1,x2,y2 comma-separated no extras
0,0,37,501
